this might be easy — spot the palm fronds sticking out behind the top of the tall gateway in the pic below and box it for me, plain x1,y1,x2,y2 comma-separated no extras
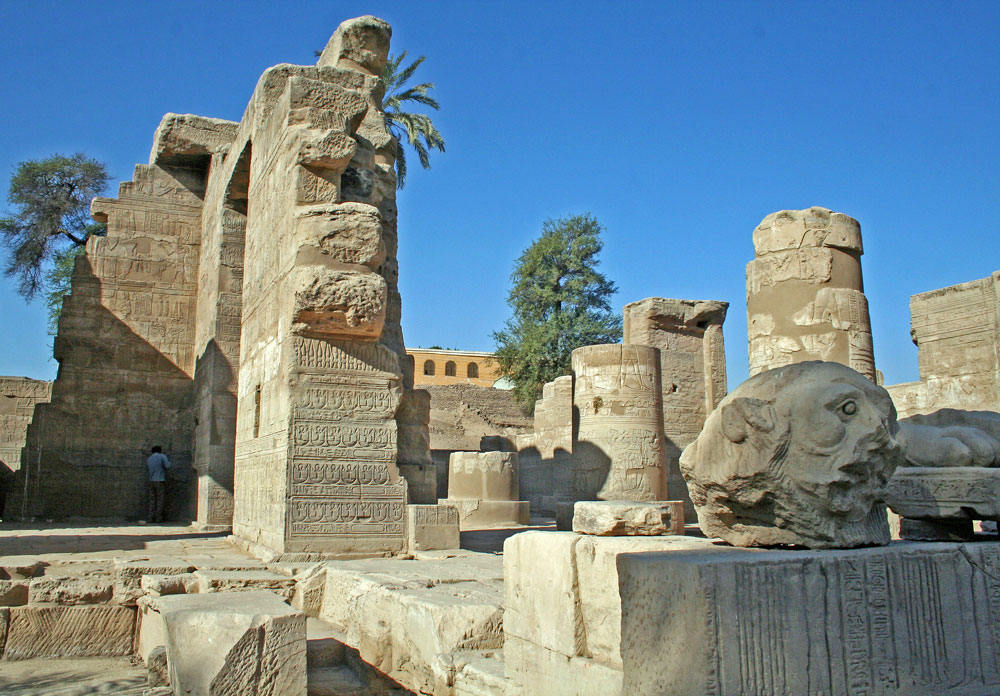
382,51,444,189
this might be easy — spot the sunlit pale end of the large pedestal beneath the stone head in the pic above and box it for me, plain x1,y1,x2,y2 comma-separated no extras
504,532,712,695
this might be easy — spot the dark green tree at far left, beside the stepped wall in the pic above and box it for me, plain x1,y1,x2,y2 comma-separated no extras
0,153,108,326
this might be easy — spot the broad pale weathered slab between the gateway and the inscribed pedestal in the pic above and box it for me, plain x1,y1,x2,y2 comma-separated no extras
320,554,504,693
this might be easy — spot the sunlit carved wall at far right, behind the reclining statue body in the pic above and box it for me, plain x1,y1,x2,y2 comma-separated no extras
886,271,1000,418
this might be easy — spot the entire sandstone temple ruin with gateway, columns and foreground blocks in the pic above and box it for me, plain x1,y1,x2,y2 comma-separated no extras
0,17,1000,696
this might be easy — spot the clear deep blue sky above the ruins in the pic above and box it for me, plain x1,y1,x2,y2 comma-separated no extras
0,0,1000,387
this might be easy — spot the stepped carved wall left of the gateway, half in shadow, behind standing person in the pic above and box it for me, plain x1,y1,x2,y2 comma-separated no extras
16,162,204,519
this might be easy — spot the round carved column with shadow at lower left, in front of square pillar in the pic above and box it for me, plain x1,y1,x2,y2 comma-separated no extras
572,344,667,500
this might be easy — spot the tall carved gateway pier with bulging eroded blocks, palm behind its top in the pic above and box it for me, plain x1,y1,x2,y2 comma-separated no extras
230,17,412,557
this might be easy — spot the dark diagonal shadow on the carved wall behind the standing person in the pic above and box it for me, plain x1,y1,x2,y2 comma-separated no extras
5,259,197,521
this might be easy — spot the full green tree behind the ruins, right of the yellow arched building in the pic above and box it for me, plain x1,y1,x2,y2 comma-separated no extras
493,213,622,411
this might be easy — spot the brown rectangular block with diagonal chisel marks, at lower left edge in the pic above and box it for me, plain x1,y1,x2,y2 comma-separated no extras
4,605,135,660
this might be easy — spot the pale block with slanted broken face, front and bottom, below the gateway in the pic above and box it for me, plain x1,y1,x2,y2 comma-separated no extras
156,592,306,696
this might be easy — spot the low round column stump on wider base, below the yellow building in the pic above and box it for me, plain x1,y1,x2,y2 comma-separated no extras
439,452,529,529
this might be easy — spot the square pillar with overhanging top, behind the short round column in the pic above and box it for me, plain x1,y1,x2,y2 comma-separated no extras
622,297,729,520
